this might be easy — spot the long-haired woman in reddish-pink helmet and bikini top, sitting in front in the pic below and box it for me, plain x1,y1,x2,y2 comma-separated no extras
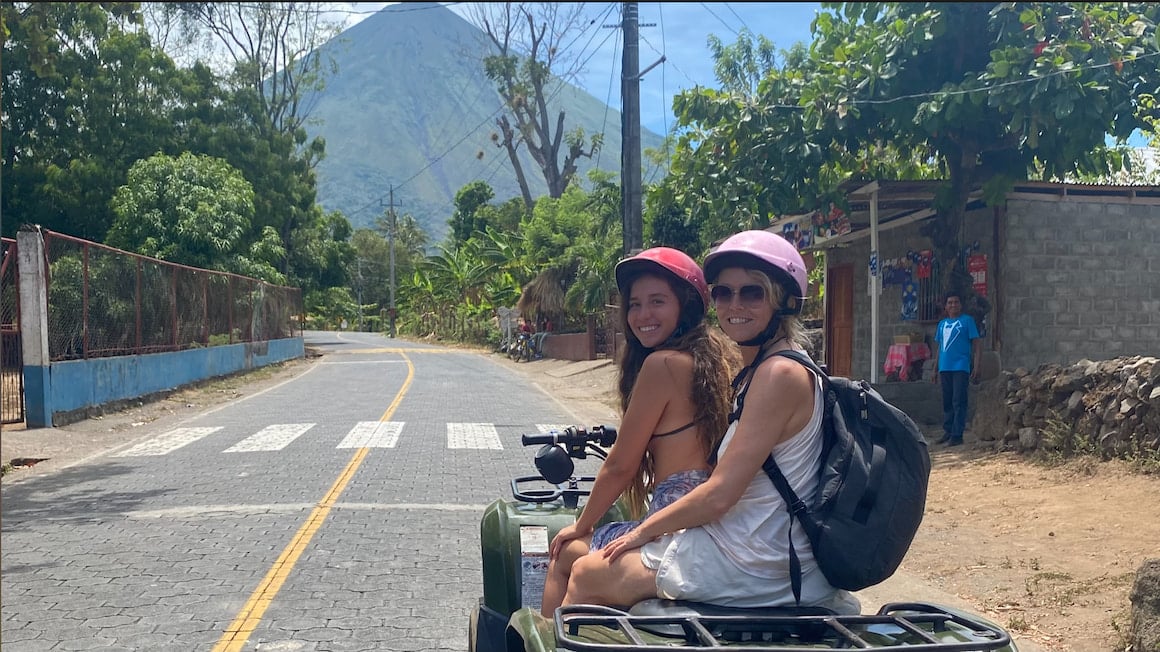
541,247,740,617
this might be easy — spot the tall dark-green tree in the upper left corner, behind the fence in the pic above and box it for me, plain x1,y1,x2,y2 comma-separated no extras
0,2,182,240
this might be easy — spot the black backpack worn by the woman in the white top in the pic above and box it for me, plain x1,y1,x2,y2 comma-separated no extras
730,350,930,602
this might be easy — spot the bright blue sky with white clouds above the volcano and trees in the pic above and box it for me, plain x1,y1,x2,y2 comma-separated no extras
335,2,821,135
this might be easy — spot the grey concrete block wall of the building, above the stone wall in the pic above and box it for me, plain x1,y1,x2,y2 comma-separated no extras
1000,197,1160,369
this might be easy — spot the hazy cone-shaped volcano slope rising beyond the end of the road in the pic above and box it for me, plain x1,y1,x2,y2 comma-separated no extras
304,2,662,244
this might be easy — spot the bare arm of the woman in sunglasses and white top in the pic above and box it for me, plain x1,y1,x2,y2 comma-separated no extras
603,357,814,559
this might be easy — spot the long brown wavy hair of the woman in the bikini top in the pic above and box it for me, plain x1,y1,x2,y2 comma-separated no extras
618,270,741,519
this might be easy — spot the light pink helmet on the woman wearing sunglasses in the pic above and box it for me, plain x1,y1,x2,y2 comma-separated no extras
705,230,809,299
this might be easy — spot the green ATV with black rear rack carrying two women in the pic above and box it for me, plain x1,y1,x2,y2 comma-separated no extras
467,426,1016,652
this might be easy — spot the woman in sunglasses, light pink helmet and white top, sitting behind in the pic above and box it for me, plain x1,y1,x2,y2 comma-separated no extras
565,231,860,614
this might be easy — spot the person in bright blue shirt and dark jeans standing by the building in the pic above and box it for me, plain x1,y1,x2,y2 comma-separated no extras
931,294,980,445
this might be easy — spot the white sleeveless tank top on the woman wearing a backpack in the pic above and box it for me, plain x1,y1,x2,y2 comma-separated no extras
703,372,824,579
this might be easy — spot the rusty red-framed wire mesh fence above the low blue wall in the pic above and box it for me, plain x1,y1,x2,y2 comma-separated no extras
44,231,303,362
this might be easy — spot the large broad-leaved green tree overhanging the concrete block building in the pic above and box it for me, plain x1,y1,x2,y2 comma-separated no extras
799,2,1160,295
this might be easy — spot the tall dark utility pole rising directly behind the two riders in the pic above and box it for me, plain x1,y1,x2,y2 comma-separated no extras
621,2,644,255
